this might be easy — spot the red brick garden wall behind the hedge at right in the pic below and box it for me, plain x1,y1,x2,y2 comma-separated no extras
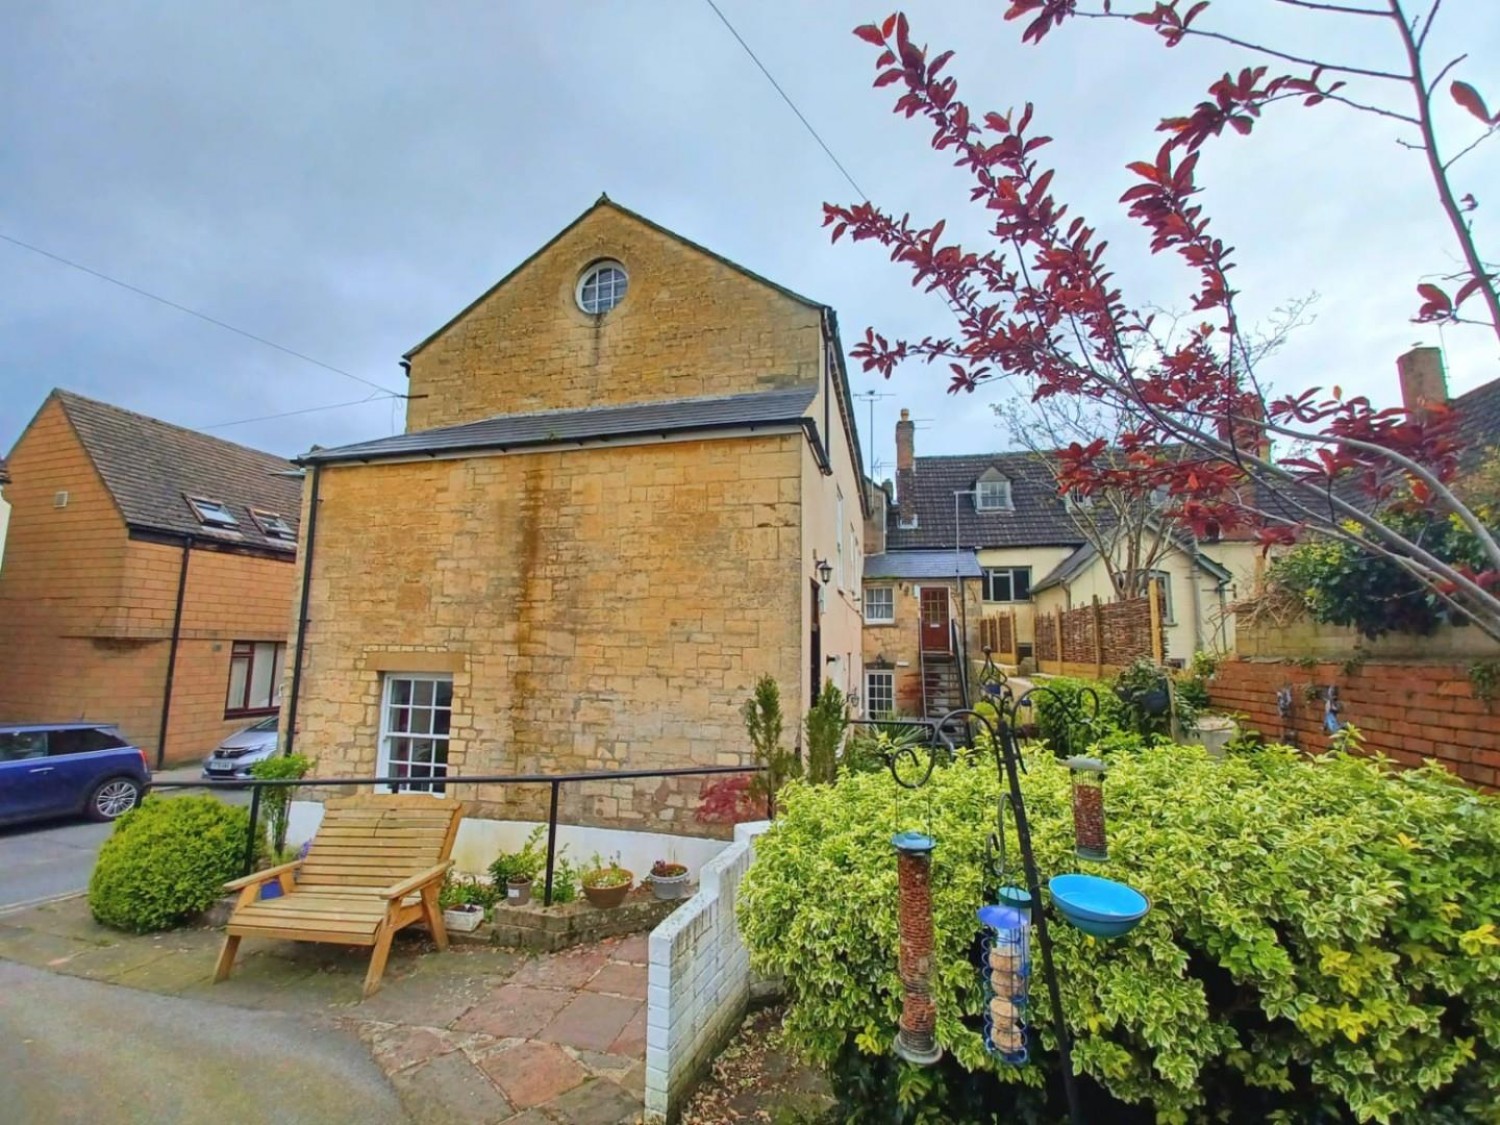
1209,660,1500,788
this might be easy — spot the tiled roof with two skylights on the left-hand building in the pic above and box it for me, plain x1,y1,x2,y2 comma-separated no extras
53,390,302,555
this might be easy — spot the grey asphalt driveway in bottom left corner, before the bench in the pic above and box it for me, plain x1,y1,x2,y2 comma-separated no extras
0,960,410,1125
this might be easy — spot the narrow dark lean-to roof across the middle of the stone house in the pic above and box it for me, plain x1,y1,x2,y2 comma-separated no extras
299,387,818,465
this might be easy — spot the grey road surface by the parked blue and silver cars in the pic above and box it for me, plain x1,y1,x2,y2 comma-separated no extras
0,767,251,914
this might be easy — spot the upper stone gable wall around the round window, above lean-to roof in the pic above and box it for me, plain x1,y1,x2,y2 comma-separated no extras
407,200,824,432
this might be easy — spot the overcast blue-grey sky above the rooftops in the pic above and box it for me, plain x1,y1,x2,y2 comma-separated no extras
0,0,1500,473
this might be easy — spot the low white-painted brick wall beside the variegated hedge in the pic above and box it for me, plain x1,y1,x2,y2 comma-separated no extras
647,821,771,1122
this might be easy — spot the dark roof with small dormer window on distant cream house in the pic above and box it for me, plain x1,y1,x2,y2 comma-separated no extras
885,452,1083,551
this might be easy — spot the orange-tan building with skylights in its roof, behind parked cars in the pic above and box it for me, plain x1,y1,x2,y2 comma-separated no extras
0,390,300,764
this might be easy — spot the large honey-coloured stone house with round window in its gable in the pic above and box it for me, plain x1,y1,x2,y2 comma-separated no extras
288,198,867,828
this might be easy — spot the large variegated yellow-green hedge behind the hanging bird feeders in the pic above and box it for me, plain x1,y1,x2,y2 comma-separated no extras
740,746,1500,1122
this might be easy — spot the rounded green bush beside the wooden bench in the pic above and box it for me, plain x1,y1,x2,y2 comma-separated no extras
89,797,251,933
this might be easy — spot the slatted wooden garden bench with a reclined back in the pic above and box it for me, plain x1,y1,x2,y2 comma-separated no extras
213,794,465,996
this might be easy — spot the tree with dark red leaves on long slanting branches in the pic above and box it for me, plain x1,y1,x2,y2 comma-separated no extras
824,0,1500,638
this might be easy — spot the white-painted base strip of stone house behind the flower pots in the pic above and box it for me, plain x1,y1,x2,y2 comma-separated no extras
287,801,729,890
